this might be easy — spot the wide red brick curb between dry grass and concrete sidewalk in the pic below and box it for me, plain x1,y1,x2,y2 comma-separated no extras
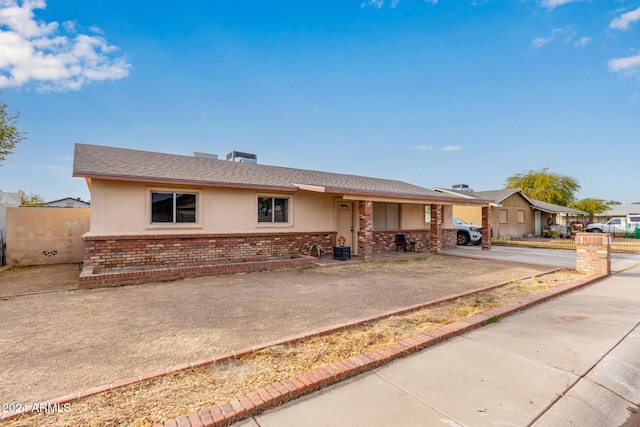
153,275,607,427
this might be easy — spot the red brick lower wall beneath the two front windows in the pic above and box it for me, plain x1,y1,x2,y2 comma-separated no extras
83,232,336,273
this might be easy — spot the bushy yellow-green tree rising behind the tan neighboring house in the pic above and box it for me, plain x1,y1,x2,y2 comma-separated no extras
506,168,580,206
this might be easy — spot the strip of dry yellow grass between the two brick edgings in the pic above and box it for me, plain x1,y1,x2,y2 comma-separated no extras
3,270,584,427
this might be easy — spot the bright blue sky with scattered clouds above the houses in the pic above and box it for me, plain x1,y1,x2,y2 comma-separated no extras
0,0,640,203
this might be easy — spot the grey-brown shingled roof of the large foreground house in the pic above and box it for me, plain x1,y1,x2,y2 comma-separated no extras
73,144,475,204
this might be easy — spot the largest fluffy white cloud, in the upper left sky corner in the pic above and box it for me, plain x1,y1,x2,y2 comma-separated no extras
0,0,131,91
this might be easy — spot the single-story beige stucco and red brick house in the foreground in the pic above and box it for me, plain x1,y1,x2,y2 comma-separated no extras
73,144,490,280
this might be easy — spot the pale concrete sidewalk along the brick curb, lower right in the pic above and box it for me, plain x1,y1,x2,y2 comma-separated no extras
237,267,640,427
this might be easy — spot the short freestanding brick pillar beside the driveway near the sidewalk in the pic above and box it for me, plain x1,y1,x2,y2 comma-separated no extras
576,233,611,275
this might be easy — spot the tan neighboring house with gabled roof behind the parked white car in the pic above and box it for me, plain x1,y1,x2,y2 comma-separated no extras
436,188,584,239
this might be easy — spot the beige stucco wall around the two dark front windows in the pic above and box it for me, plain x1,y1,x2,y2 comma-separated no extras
89,179,336,236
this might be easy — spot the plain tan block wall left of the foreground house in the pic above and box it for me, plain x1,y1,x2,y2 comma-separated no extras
7,207,90,265
